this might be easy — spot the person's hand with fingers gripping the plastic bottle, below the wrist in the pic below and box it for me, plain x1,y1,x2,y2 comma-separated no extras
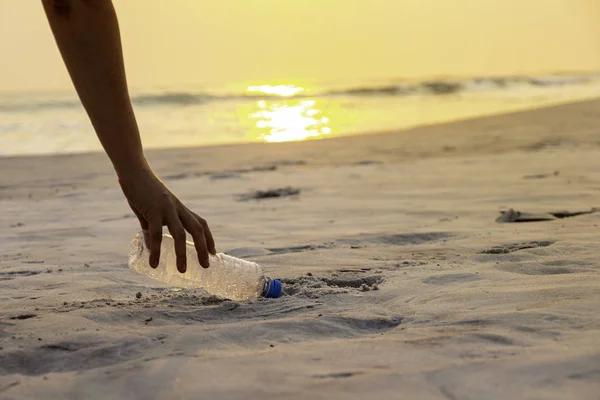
119,169,216,273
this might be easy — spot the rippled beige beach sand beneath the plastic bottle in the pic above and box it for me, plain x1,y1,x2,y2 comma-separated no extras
0,101,600,400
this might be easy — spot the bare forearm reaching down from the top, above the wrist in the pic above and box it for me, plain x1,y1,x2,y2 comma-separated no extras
42,0,149,178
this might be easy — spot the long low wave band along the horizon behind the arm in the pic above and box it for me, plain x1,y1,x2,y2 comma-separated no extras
0,75,600,113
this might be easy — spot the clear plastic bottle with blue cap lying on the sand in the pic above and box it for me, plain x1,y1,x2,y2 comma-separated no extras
129,232,281,301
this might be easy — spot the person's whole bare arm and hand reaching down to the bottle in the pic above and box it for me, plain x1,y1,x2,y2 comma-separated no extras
42,0,216,273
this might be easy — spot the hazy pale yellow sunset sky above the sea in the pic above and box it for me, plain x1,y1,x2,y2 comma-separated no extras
0,0,600,92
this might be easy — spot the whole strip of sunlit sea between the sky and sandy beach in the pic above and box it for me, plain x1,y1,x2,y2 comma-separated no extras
0,75,600,156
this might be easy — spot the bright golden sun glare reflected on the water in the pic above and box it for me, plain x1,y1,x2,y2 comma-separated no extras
238,84,336,142
